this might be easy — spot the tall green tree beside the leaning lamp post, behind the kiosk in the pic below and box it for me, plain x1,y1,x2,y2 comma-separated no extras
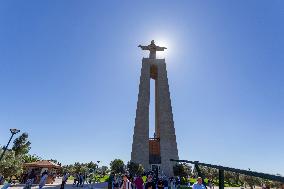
12,133,31,156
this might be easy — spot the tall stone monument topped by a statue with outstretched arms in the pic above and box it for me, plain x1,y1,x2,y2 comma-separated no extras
131,40,178,176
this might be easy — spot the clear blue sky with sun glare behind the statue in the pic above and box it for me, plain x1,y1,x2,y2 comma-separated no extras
0,0,284,175
